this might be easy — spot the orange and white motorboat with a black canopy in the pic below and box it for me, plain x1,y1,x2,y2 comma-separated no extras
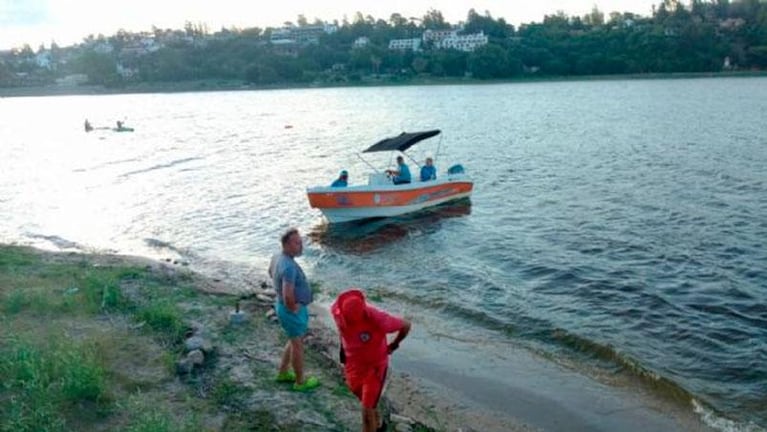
306,129,474,223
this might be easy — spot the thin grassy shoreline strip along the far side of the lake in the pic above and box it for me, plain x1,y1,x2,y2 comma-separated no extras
0,71,767,98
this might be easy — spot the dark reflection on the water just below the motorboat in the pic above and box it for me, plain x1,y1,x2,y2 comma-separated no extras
308,198,471,254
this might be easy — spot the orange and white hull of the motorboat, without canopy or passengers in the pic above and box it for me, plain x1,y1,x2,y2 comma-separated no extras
307,176,474,223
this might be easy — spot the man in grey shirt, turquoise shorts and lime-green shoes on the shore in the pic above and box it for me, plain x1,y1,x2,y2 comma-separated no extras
269,228,320,391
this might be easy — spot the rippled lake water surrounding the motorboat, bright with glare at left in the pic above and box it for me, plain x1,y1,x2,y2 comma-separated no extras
0,77,767,431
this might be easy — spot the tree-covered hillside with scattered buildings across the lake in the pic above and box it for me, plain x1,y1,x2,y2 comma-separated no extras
0,0,767,89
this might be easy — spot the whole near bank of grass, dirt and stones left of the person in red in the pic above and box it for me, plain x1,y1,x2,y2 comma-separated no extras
0,245,444,432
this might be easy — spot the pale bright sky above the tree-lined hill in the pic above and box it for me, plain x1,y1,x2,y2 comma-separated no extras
0,0,661,50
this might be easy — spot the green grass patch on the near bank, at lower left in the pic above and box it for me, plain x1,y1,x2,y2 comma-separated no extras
0,247,199,432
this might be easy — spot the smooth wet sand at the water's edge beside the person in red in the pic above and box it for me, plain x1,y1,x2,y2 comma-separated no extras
318,305,713,432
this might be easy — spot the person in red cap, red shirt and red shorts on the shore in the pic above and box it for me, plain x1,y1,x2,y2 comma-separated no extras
330,289,410,432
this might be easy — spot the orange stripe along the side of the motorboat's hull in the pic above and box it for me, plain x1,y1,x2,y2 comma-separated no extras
308,182,473,209
